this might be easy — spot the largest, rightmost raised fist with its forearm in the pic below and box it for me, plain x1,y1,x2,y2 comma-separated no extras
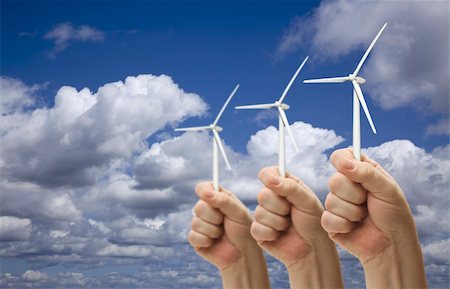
321,149,427,288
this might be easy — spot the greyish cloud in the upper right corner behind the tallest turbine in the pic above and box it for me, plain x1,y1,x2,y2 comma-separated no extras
278,0,450,120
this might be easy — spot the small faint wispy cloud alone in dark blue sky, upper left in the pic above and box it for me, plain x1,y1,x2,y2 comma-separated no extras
44,22,105,57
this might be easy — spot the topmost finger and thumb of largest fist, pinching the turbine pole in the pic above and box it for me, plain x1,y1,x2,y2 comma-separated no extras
330,150,402,203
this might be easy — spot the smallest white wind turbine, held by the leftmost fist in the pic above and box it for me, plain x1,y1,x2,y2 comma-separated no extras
175,84,239,192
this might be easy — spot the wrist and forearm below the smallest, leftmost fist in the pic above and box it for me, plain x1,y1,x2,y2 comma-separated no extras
220,247,270,289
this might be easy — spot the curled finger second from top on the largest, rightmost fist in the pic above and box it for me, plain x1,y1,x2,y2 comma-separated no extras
328,172,367,205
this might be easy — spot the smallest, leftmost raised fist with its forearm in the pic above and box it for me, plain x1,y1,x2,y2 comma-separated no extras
188,182,270,289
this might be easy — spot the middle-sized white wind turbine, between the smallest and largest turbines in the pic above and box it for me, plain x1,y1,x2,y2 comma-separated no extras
235,56,308,177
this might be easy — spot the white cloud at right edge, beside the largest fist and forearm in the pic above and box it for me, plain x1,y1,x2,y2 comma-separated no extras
367,140,450,241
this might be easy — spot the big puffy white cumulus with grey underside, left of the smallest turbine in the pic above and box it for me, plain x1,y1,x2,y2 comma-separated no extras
0,75,207,187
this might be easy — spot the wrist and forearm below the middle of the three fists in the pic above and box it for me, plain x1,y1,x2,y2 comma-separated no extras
288,241,344,289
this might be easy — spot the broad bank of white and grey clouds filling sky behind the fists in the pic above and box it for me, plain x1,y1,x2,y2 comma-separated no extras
0,75,450,288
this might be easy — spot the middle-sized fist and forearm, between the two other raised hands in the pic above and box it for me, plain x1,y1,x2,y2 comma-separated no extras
251,167,343,288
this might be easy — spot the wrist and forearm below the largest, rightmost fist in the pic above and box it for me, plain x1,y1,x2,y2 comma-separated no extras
363,236,427,289
